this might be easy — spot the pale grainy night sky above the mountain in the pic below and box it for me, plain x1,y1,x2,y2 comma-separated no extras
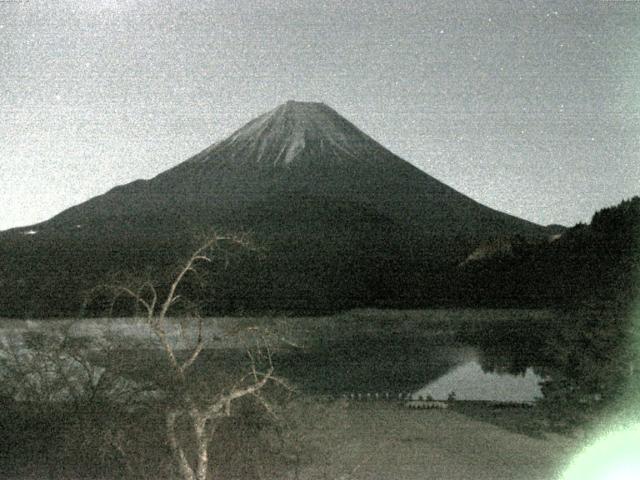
0,0,640,229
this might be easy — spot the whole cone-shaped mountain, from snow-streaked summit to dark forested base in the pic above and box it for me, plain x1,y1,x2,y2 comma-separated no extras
0,102,547,315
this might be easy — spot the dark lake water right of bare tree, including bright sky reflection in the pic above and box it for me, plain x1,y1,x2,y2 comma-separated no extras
278,312,553,402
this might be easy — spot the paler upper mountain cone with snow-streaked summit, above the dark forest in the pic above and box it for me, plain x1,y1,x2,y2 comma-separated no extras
23,102,546,237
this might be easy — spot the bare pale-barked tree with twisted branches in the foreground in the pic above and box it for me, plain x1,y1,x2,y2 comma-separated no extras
96,235,288,480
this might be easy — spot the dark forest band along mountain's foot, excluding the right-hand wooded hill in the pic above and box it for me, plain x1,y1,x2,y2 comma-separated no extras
0,206,474,318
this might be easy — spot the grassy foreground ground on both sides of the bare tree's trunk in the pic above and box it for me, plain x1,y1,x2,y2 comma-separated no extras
0,396,581,480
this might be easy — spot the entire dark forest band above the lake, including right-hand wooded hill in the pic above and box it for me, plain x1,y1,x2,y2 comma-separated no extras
0,197,640,318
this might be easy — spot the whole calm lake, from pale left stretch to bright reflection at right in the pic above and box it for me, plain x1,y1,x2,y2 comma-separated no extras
0,310,552,402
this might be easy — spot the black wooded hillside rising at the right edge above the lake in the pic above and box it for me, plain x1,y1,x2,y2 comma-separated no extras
458,197,640,308
